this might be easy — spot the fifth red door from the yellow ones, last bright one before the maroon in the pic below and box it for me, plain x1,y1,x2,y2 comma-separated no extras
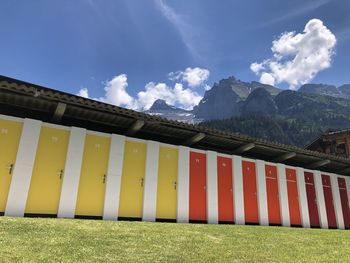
286,168,301,226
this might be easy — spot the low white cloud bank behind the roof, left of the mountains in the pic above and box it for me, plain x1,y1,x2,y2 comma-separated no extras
77,74,202,110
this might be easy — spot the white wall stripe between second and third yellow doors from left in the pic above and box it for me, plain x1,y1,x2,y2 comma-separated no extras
57,127,86,218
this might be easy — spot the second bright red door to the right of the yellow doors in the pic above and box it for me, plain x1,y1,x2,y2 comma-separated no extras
217,156,234,223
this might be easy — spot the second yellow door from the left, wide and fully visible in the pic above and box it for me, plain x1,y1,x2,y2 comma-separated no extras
25,127,69,215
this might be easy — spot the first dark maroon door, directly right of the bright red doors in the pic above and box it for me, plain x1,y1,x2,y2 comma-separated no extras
304,172,320,227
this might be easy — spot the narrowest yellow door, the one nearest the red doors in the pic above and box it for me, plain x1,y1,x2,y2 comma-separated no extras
157,146,178,219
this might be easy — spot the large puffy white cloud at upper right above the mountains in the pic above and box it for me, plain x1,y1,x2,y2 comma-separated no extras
250,19,337,89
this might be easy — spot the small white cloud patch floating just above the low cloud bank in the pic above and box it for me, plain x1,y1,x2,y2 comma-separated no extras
168,67,210,87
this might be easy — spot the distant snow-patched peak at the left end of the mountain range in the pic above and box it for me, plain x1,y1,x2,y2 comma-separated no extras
145,99,202,124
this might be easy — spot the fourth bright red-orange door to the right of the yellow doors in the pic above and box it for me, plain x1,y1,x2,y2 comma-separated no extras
265,165,281,225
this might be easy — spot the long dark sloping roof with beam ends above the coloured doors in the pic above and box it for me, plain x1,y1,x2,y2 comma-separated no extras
0,75,350,175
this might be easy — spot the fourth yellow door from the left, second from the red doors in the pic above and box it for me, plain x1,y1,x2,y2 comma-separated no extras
119,141,147,218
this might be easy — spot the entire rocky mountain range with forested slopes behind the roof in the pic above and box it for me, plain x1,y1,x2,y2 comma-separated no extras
146,77,350,146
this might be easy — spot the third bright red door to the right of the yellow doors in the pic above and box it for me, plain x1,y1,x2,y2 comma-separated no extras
242,161,259,224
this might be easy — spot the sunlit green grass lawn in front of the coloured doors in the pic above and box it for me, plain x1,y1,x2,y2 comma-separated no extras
0,217,350,262
